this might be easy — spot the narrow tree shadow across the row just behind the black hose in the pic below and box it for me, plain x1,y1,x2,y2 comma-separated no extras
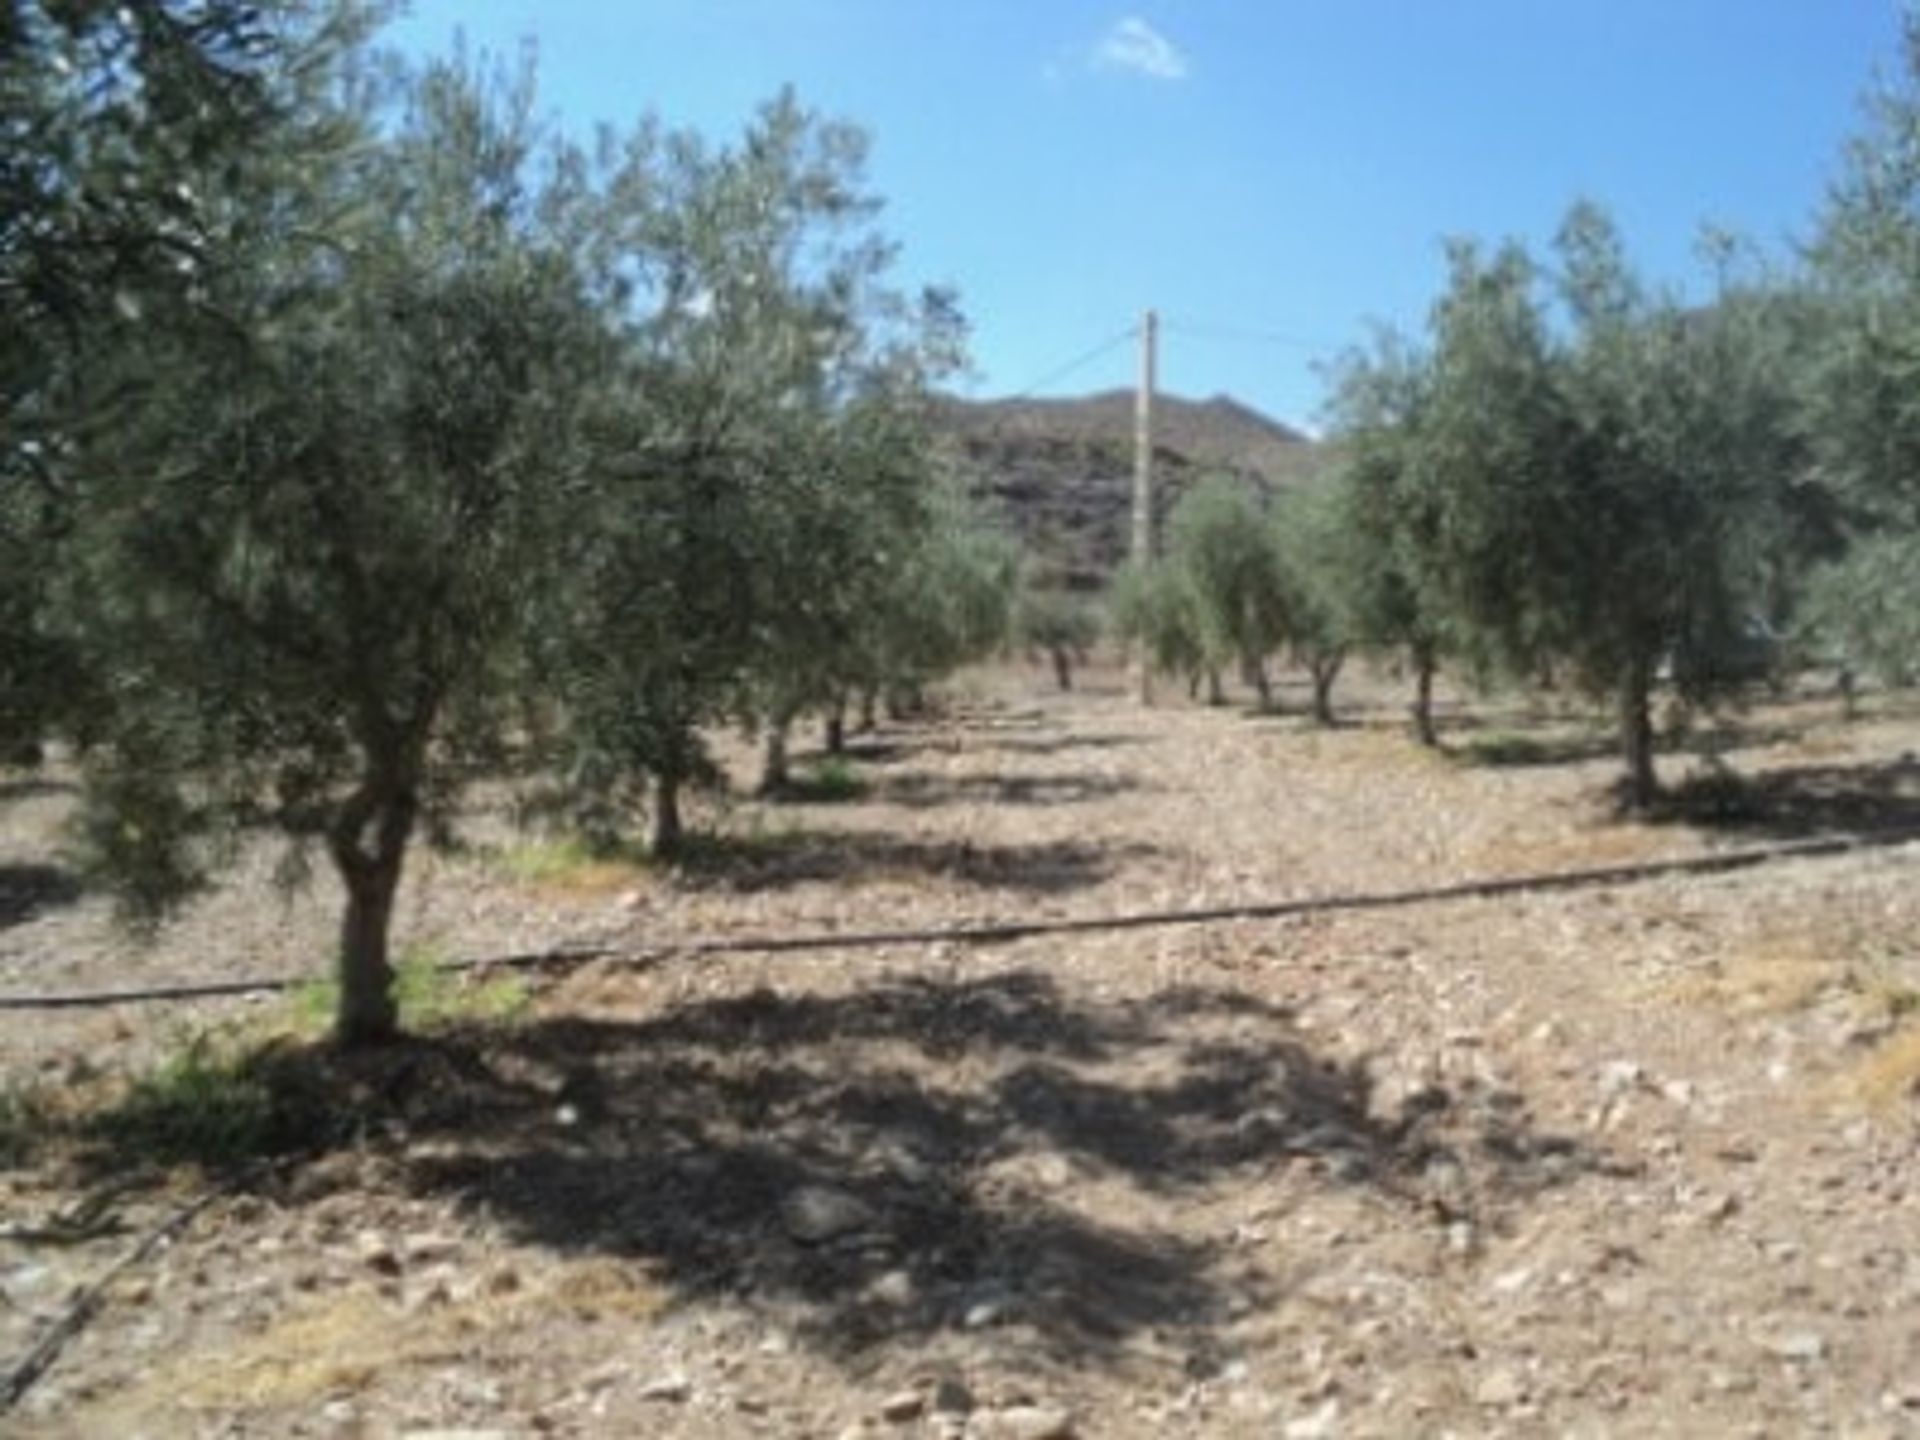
674,829,1160,895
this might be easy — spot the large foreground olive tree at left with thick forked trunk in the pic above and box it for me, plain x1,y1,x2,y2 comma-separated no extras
58,53,599,1044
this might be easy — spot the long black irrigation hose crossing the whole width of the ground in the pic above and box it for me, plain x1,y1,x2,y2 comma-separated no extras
0,831,1896,1010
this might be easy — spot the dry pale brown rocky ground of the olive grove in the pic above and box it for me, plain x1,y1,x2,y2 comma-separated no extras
0,674,1920,1440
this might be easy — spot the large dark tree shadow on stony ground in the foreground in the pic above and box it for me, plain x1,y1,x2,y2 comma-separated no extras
101,972,1620,1365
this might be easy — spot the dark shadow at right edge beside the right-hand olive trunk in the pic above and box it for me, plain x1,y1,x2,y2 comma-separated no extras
1655,756,1920,841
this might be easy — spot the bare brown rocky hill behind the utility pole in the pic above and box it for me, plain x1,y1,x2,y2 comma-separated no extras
937,390,1323,589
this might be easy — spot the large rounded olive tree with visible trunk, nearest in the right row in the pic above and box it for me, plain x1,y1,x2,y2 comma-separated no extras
1417,205,1799,808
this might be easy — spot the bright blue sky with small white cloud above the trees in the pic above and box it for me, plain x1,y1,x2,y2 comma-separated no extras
390,0,1899,424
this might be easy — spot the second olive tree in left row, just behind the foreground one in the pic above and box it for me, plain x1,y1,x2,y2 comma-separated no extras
545,94,954,852
